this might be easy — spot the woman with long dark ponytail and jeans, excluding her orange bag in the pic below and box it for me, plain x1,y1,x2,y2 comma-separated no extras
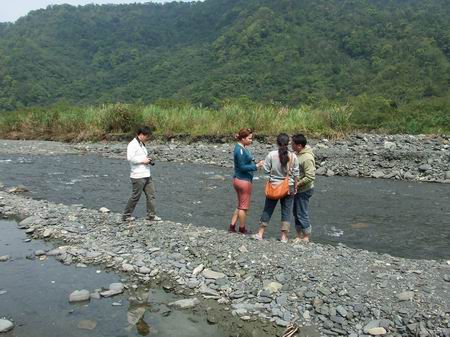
254,133,299,242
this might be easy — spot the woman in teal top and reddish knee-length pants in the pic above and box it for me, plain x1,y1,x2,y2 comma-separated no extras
228,128,264,234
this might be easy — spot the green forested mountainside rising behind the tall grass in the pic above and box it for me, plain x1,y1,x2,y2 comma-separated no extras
0,0,450,110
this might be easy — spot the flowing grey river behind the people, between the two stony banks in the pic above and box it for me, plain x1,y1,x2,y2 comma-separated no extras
0,155,450,259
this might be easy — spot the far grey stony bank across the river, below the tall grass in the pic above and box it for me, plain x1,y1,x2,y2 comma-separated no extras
0,134,450,183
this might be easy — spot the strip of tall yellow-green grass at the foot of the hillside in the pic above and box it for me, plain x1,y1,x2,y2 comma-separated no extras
0,97,450,141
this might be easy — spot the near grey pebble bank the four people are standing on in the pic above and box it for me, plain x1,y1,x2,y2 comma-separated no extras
0,191,450,337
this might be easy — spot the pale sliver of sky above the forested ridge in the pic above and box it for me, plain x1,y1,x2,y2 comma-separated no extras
0,0,190,22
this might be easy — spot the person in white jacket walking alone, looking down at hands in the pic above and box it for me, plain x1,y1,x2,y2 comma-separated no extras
122,126,161,221
